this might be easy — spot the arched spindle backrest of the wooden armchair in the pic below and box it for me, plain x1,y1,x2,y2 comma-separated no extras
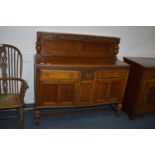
0,44,23,94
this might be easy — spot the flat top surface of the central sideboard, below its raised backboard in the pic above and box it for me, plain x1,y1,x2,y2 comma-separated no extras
36,55,129,68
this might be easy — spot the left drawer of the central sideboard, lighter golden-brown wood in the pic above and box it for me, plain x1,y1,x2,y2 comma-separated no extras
39,70,79,80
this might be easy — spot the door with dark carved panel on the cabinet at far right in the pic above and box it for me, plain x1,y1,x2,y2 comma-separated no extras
140,80,155,109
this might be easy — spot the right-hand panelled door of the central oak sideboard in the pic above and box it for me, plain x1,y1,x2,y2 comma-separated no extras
94,78,125,104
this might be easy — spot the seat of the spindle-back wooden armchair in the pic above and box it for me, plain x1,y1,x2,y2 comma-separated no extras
0,94,22,109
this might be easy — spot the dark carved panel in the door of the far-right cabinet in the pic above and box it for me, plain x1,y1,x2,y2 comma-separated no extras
145,87,155,104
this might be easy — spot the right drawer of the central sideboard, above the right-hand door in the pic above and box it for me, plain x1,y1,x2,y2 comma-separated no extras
96,70,127,79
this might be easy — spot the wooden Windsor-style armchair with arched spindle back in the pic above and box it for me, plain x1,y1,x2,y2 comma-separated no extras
0,44,28,128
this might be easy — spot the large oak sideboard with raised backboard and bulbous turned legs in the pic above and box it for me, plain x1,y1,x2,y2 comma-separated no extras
35,32,129,124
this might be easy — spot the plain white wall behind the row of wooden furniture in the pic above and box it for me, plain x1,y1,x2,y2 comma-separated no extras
0,26,155,103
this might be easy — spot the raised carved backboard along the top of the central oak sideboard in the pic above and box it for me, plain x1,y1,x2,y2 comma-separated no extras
36,32,120,58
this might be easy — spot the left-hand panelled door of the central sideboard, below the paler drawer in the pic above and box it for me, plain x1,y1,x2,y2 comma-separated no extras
38,81,77,107
